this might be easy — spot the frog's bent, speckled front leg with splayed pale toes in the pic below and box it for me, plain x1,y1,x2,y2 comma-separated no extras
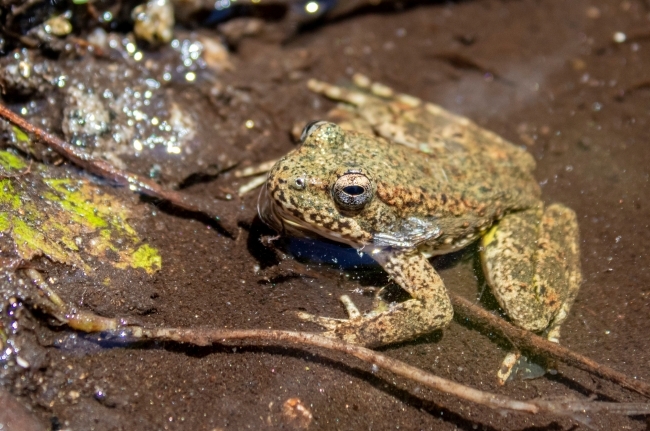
299,250,454,347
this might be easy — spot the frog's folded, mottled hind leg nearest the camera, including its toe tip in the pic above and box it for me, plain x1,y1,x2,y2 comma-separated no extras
481,204,582,383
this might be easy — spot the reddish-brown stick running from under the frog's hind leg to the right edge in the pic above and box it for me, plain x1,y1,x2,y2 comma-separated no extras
450,295,650,397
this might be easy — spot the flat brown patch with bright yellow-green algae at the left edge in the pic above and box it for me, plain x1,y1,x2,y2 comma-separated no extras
0,151,161,274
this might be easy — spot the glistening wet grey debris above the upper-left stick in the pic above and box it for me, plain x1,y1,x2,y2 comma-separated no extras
0,46,228,182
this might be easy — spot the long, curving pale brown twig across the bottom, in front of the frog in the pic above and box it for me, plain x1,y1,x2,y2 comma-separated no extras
20,268,650,423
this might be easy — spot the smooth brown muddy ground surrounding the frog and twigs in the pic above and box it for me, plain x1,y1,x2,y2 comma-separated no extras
1,0,650,430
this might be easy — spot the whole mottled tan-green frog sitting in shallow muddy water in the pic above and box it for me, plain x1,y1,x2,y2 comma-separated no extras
258,75,582,381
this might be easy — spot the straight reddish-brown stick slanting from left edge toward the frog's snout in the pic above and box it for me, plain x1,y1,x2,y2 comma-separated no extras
0,103,237,236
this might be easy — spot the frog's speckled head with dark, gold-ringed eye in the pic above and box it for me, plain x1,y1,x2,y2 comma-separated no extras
258,121,375,247
